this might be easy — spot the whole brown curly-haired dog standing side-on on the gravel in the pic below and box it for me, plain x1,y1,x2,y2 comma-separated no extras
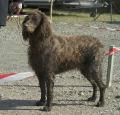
22,11,105,111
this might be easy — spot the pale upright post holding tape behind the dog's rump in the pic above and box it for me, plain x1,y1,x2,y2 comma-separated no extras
106,45,114,87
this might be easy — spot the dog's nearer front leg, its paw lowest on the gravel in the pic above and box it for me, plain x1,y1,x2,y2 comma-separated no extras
44,73,55,111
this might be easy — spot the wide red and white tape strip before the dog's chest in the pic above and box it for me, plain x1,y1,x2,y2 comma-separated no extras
0,72,34,84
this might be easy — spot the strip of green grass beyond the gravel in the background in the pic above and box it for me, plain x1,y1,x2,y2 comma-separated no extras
23,8,120,23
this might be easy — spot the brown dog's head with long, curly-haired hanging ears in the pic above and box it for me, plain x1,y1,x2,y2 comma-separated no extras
22,10,51,40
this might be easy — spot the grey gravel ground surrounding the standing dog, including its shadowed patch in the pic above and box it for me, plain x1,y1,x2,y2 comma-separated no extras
0,15,120,115
